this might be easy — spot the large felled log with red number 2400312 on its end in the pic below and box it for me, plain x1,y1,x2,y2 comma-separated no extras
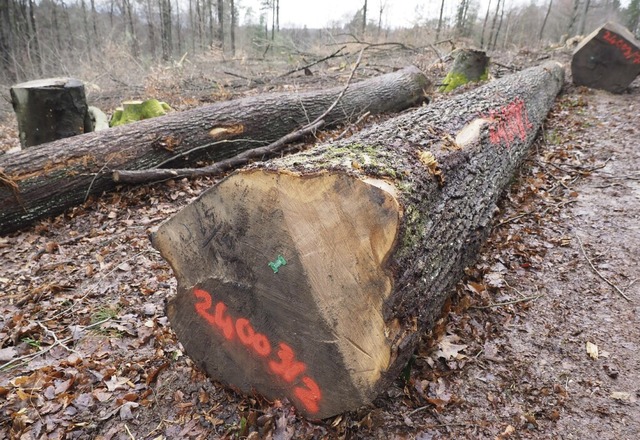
152,62,564,418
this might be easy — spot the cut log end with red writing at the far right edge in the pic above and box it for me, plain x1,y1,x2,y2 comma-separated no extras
571,23,640,93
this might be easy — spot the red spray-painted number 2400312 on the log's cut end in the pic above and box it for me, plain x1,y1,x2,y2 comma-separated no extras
193,289,322,414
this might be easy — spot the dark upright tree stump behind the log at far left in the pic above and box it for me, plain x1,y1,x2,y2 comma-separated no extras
11,78,93,148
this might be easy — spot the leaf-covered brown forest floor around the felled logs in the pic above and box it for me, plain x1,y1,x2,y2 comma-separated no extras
0,46,640,440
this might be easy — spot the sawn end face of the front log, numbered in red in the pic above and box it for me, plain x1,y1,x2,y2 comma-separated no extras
153,170,401,418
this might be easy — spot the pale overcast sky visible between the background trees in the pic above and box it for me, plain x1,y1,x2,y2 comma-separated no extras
241,0,630,28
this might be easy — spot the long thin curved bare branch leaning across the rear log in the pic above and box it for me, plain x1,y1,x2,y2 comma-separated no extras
113,48,366,183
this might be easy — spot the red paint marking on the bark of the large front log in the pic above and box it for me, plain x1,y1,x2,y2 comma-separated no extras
488,98,533,148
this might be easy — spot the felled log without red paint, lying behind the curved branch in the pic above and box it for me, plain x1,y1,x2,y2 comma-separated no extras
0,67,429,234
